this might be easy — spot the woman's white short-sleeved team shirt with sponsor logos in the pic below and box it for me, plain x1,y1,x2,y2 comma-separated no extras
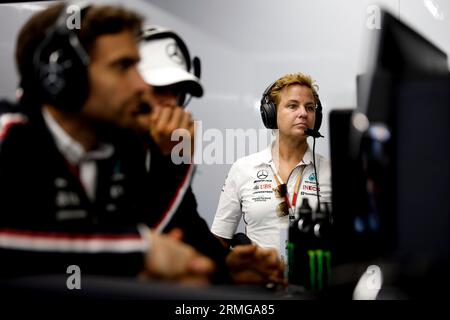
211,146,331,252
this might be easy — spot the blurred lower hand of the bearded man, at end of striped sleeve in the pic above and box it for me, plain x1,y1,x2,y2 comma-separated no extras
140,229,215,284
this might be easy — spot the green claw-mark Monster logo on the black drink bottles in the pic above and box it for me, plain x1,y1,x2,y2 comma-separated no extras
308,250,331,290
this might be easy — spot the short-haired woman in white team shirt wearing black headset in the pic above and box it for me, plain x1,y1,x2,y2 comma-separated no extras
211,73,331,253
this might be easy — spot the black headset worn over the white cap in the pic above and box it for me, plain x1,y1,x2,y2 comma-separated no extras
139,26,201,106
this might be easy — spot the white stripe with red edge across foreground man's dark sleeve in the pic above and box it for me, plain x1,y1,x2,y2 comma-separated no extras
0,231,148,253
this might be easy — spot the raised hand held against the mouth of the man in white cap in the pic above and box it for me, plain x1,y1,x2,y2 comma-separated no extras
138,106,195,156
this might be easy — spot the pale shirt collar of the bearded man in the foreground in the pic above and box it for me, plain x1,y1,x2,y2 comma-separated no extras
42,109,114,164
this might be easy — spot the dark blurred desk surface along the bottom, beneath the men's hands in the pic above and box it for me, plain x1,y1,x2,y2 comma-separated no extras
0,275,315,300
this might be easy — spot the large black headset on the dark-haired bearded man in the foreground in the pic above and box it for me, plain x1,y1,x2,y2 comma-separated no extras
33,3,90,112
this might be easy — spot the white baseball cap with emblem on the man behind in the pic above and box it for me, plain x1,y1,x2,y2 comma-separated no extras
138,33,203,97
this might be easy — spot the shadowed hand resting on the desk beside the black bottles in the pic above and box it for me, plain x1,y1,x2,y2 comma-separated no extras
226,245,286,285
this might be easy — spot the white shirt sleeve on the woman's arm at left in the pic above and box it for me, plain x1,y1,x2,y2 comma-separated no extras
211,163,242,239
